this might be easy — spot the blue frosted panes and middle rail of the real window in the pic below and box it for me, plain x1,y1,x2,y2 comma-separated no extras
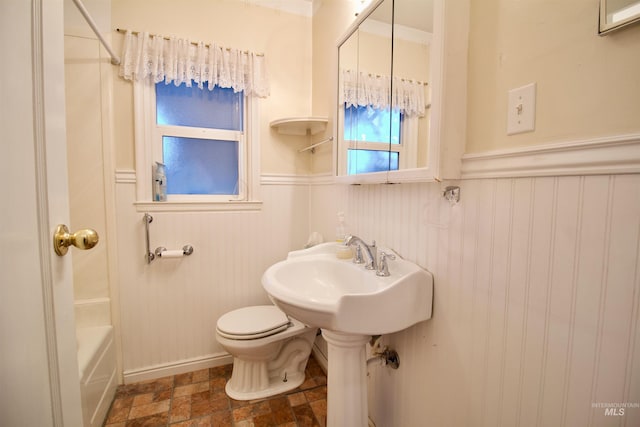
156,82,245,197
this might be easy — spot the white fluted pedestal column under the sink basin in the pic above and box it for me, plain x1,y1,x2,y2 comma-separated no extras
322,329,370,427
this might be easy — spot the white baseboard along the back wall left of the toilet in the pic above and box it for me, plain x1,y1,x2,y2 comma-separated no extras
124,353,233,384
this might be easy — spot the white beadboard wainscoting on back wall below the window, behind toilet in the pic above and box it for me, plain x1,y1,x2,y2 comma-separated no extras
116,171,316,383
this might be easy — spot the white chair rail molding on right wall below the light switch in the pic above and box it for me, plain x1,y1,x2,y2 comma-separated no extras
462,134,640,179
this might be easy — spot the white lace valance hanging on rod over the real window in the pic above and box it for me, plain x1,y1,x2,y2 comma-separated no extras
120,31,269,98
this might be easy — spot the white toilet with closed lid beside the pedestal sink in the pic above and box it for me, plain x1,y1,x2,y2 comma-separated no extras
216,305,317,400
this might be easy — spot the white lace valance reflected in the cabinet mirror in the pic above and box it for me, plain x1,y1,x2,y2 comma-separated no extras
340,70,426,116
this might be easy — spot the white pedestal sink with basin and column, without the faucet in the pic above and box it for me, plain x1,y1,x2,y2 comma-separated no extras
262,243,433,427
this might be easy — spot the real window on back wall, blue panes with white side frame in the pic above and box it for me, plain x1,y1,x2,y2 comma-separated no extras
135,82,258,209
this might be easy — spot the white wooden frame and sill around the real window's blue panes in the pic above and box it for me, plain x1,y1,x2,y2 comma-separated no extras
133,79,261,212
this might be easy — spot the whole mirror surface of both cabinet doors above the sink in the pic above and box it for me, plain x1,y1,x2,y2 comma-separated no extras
337,0,433,179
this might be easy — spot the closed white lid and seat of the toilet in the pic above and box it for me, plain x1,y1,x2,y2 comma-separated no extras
217,305,289,339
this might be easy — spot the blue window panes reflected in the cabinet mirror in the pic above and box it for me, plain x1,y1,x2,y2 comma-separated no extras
344,105,403,175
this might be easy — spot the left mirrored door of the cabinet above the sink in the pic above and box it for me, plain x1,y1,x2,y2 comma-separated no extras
337,0,392,175
